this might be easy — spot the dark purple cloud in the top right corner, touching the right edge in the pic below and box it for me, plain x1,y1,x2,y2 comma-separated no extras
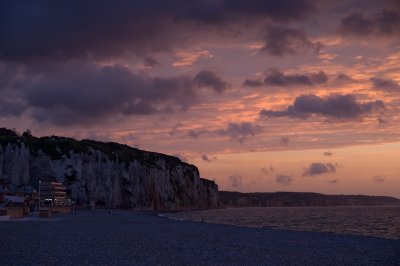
340,9,400,37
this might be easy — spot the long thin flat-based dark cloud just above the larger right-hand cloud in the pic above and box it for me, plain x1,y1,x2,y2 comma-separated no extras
243,68,329,87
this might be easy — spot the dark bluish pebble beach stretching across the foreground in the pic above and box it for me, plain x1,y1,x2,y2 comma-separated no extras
0,211,400,265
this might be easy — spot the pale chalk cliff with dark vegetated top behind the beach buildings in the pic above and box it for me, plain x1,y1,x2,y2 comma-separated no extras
0,133,218,209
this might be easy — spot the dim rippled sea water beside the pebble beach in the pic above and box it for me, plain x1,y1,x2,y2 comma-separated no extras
165,207,400,239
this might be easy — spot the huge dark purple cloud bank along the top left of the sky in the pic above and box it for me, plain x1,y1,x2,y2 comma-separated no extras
0,0,315,60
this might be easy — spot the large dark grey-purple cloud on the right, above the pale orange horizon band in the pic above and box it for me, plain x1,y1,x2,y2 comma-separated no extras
260,94,385,120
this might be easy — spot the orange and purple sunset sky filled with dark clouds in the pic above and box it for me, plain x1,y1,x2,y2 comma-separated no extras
0,0,400,197
